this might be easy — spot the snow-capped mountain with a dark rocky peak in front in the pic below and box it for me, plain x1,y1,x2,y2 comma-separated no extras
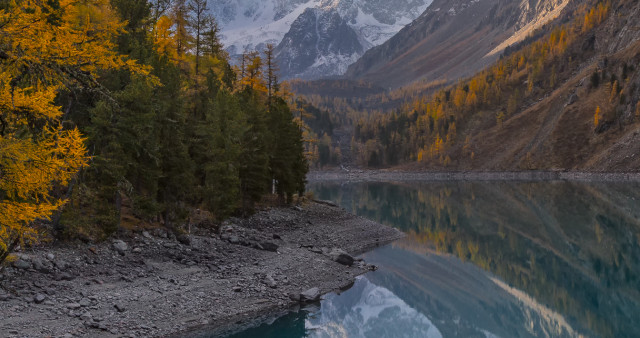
209,0,433,78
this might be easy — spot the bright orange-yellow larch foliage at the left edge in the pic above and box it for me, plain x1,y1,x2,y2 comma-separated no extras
0,0,147,263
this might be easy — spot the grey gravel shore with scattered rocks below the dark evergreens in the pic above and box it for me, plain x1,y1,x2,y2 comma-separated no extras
0,202,402,337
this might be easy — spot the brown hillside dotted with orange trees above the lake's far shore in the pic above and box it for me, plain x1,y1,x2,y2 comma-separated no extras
352,0,640,171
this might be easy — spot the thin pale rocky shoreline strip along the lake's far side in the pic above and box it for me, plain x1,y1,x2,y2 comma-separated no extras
307,169,640,182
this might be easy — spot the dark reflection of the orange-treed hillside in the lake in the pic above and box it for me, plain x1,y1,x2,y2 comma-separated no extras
311,182,640,337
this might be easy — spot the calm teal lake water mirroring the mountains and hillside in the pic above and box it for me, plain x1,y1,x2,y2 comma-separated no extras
224,181,640,337
